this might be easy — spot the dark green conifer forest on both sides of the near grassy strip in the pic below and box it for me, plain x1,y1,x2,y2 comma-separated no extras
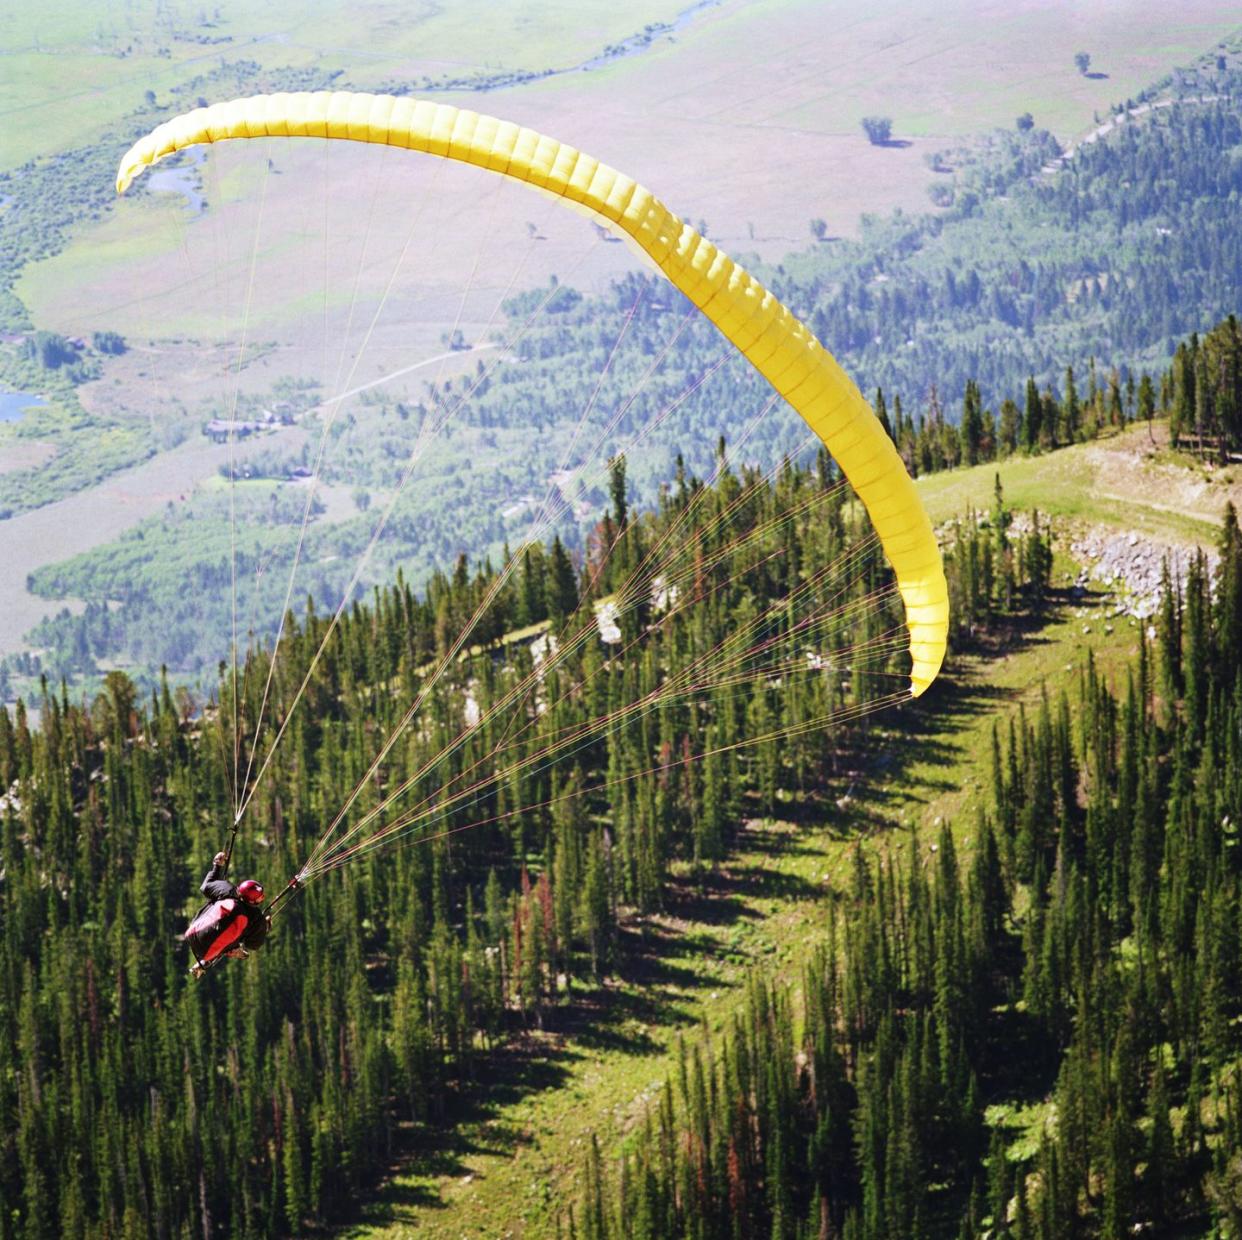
0,315,1242,1240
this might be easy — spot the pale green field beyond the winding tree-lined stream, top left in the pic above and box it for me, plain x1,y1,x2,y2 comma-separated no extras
0,0,700,168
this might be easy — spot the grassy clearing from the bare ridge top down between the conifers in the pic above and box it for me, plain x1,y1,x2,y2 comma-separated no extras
347,427,1197,1240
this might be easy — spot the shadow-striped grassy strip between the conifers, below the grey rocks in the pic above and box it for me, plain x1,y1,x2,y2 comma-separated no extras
344,613,1136,1240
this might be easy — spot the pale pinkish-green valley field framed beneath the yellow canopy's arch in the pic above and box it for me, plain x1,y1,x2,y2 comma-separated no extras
17,142,635,350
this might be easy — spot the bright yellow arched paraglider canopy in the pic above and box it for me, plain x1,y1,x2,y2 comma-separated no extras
117,91,949,697
